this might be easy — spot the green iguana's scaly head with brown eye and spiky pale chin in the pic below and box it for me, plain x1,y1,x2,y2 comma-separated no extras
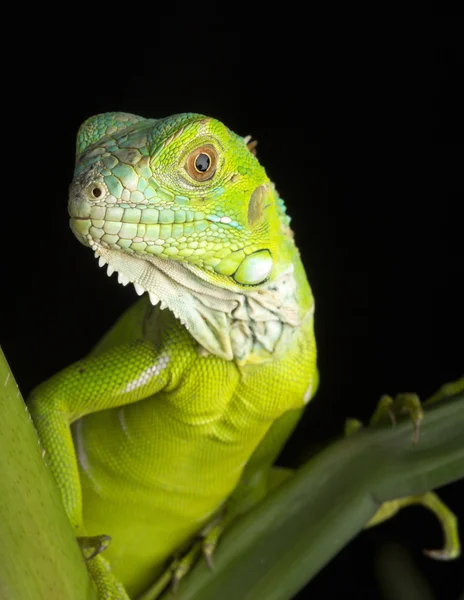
68,113,300,358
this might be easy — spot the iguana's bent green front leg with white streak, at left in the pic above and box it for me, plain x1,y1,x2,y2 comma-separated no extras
29,340,176,600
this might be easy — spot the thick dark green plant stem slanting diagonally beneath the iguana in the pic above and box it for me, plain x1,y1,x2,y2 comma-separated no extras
162,384,464,600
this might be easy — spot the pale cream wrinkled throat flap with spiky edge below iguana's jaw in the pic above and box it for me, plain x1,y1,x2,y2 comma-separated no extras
93,237,309,364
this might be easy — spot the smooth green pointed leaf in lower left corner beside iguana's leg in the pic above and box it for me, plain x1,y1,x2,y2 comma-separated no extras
0,348,96,600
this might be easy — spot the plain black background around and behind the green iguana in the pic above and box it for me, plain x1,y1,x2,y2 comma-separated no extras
1,10,464,600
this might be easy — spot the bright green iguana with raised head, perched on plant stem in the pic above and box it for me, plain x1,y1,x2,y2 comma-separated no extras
30,113,317,598
